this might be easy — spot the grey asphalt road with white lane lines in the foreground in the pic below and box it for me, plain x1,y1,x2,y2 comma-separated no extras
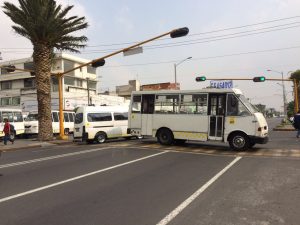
0,134,300,225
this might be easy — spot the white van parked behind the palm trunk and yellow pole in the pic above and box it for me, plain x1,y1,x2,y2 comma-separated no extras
25,111,75,135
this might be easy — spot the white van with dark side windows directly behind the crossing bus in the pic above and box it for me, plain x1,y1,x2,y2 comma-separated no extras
74,106,132,143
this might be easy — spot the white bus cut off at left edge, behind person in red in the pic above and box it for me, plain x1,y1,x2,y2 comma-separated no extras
0,108,24,138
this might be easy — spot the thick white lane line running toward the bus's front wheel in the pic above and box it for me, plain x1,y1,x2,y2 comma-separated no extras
156,156,242,225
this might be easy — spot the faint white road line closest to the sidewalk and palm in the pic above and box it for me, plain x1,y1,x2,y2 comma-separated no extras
0,147,110,169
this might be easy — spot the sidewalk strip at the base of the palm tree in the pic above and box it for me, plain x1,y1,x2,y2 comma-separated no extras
0,138,73,152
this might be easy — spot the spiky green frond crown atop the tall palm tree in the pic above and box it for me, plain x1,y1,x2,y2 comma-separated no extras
2,0,88,52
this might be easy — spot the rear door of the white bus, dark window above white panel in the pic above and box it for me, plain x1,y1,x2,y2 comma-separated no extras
141,94,155,135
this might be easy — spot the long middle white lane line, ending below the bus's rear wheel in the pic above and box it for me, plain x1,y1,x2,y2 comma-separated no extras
0,151,168,203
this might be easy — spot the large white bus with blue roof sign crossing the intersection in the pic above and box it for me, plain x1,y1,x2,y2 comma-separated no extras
127,88,268,150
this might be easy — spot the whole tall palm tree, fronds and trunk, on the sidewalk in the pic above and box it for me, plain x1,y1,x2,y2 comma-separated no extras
2,0,88,141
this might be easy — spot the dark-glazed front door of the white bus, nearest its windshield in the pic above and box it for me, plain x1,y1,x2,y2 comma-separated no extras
208,94,226,140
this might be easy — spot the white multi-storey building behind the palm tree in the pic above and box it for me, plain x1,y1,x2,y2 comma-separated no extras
0,53,125,113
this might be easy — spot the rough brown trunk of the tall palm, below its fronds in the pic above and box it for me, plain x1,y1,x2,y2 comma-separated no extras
33,43,53,141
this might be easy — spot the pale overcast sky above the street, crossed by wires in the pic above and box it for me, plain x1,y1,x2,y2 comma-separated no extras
0,0,300,110
